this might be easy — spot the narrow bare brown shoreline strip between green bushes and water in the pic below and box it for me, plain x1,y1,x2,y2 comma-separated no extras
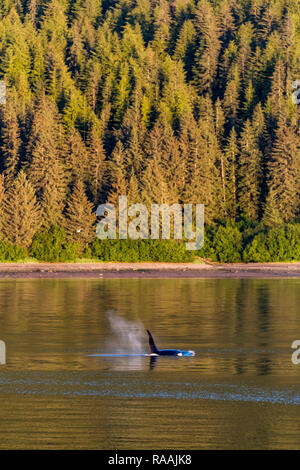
0,262,300,279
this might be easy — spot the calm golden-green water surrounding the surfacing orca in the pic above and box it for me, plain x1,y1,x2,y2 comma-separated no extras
0,279,300,449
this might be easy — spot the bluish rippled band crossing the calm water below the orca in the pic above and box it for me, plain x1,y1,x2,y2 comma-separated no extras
0,372,300,405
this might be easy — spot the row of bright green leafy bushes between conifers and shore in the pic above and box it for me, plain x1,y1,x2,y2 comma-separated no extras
0,219,300,263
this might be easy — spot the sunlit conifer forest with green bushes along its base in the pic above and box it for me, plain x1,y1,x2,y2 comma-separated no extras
0,0,300,262
